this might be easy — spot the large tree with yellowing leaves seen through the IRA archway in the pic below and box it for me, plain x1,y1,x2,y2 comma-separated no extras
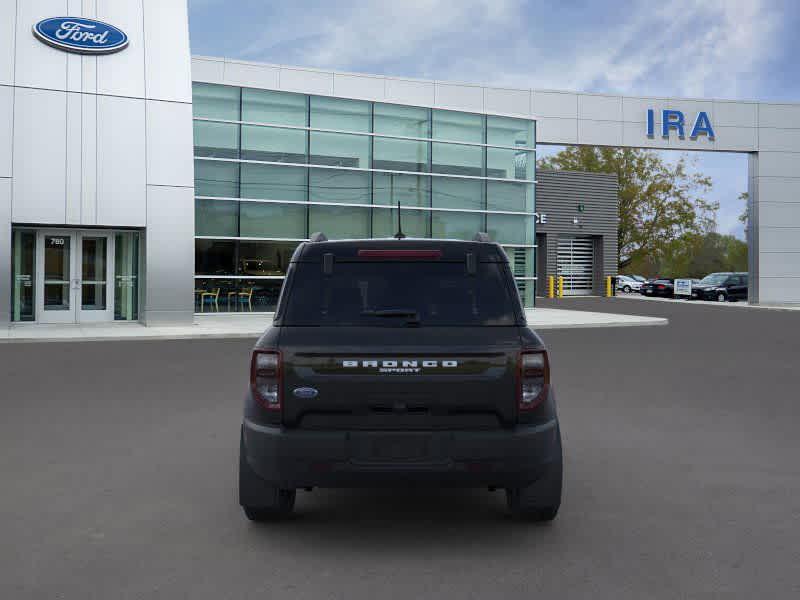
538,146,719,269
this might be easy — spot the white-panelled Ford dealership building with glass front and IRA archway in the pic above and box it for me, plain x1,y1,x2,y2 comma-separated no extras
0,0,800,325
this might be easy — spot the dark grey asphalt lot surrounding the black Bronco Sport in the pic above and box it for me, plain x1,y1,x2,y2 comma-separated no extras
0,299,800,600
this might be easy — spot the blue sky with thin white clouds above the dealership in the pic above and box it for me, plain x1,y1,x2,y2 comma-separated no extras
189,0,800,237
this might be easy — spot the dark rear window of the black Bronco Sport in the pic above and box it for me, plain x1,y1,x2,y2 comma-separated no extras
283,262,519,327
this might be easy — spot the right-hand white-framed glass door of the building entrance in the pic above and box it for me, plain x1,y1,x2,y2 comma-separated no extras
76,231,114,323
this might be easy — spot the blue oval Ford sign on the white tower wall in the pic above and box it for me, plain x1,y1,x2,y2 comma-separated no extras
33,17,128,54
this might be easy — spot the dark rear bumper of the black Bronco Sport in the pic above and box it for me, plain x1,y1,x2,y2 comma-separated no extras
242,412,561,489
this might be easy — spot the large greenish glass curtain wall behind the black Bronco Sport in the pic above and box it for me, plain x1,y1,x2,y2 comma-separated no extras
193,83,536,312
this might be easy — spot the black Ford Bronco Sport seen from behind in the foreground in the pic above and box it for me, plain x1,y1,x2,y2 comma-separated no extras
239,237,562,521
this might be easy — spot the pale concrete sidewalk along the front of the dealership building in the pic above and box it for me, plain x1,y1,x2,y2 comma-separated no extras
0,308,668,343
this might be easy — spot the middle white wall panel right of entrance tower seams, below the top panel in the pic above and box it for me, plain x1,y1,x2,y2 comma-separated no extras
147,100,194,187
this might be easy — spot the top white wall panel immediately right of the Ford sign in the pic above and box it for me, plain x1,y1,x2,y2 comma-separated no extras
141,0,192,102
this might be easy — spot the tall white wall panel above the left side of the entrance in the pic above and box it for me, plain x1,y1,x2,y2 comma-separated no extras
12,88,67,224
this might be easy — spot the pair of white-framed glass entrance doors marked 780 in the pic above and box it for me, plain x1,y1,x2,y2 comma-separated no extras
35,230,114,323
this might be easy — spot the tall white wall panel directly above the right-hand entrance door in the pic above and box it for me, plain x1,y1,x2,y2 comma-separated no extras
97,96,147,227
